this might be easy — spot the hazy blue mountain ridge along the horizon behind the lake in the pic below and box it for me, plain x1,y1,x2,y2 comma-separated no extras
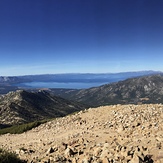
0,71,162,83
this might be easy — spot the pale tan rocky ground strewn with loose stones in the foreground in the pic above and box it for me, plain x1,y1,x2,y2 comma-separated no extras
0,104,163,163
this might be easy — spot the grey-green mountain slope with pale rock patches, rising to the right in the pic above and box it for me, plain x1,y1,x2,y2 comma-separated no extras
51,75,163,106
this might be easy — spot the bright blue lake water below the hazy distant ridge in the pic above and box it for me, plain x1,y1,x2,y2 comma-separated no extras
18,82,106,89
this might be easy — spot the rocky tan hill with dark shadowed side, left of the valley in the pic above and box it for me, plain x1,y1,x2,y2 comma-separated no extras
0,90,85,125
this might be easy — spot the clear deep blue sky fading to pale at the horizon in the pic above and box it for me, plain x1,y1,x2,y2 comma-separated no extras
0,0,163,76
